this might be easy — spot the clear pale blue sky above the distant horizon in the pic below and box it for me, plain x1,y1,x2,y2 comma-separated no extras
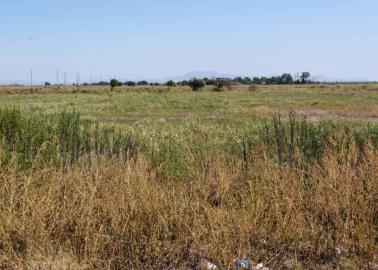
0,0,378,82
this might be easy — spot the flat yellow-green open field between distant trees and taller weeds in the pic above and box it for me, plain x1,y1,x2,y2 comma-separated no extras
0,85,378,124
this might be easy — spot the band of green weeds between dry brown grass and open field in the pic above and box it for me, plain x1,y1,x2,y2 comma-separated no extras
0,108,378,175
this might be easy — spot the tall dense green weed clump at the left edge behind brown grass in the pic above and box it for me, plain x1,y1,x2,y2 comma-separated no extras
0,108,139,168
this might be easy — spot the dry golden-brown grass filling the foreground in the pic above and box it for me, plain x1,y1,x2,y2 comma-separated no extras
0,142,378,269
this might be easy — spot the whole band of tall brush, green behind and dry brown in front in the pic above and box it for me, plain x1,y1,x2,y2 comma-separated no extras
0,109,378,269
